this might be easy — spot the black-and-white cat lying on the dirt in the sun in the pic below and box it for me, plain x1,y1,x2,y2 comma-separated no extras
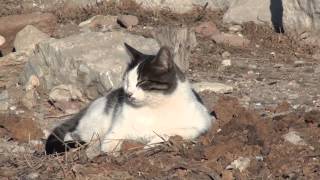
45,43,215,154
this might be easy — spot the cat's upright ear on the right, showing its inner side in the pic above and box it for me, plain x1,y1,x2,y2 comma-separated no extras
153,46,174,70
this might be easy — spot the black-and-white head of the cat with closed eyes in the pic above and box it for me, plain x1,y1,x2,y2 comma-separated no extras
123,43,184,105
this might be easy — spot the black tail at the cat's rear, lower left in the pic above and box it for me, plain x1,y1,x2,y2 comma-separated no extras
45,111,85,154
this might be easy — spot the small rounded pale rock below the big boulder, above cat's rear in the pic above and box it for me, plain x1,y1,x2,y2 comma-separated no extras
49,84,83,102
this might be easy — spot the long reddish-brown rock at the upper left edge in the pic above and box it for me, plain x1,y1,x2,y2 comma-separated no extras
0,13,57,54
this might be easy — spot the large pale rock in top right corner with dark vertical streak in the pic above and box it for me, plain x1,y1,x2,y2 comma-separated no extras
223,0,320,33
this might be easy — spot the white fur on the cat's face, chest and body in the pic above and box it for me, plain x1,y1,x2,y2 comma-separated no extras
68,67,212,152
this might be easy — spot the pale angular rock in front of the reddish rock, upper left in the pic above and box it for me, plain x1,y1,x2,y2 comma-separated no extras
13,25,50,52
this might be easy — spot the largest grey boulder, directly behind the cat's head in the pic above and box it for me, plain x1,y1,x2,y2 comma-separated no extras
21,32,159,98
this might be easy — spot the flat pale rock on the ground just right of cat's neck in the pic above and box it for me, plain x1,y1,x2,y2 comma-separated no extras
192,82,233,93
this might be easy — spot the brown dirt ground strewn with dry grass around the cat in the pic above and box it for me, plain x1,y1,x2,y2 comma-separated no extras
0,1,320,180
